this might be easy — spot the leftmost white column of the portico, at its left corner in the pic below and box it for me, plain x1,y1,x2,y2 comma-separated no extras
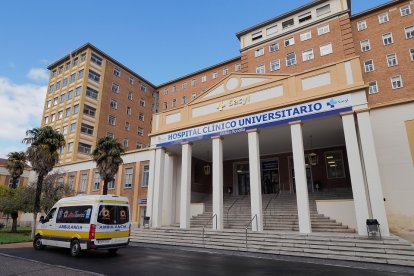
151,148,165,227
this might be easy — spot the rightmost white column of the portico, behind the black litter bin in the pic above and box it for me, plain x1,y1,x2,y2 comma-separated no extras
357,110,390,236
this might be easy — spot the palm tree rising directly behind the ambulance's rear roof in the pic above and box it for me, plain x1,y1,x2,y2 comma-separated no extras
91,137,125,195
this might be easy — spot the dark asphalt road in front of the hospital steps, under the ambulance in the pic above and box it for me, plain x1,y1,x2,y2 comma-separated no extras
0,243,414,276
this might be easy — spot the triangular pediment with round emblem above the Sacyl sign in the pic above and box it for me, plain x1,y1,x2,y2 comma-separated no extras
191,73,289,104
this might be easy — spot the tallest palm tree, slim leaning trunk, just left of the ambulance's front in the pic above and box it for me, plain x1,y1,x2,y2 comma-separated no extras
23,126,65,237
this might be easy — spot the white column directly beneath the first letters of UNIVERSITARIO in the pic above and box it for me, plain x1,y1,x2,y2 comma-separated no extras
247,129,263,231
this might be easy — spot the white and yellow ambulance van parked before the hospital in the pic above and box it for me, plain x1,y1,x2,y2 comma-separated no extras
33,195,131,256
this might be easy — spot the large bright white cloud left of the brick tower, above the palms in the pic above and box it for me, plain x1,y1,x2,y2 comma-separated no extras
0,76,47,143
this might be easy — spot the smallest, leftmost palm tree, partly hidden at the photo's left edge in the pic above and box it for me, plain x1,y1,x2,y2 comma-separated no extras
6,151,26,233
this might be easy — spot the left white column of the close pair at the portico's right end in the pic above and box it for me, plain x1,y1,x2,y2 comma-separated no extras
341,112,369,236
